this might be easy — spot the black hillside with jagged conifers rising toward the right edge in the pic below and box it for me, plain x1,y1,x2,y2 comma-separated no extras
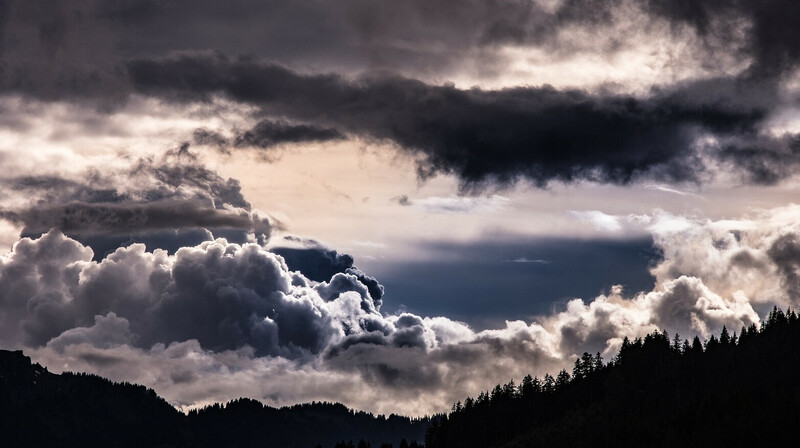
426,309,800,448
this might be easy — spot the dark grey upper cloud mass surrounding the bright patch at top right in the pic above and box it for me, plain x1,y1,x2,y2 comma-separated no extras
0,0,800,188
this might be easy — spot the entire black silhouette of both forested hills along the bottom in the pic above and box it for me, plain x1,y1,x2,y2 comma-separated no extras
0,308,800,448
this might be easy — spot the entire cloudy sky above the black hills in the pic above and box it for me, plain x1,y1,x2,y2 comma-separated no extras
0,0,800,416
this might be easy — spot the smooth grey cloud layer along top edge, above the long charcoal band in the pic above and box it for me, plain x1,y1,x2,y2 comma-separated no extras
0,0,799,89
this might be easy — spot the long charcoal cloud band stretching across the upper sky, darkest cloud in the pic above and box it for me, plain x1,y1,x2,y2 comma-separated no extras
129,55,788,186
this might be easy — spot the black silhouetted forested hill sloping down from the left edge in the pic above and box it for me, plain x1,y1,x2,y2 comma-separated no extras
0,350,428,448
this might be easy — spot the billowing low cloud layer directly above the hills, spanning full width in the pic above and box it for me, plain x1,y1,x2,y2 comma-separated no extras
0,206,800,414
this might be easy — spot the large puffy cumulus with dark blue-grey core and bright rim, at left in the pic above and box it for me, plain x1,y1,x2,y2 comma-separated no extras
0,231,344,357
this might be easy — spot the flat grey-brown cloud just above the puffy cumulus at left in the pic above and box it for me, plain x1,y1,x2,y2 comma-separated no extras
0,146,274,258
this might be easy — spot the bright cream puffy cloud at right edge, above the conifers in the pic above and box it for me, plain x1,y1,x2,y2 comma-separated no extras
650,205,799,313
